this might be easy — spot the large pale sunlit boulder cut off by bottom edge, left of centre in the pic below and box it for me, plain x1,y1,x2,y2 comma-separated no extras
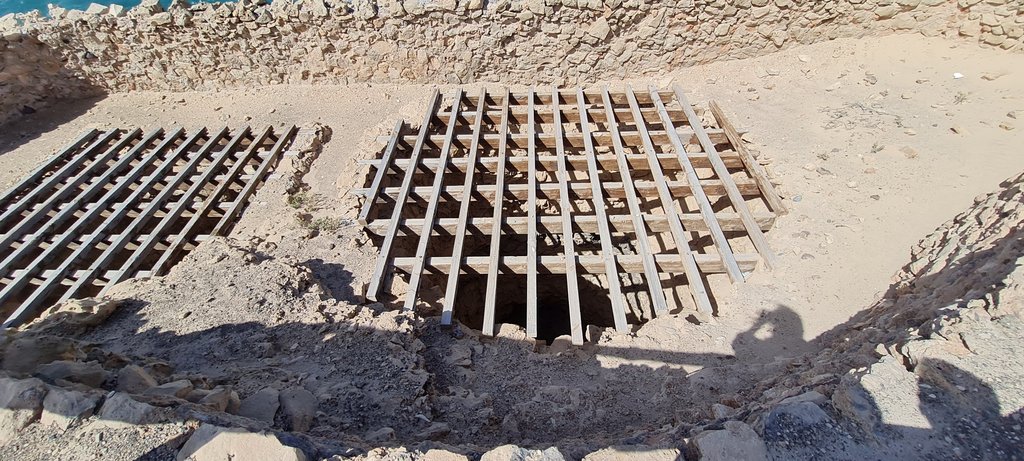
176,424,307,461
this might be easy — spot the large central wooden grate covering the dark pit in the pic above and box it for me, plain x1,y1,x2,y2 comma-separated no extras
356,87,784,344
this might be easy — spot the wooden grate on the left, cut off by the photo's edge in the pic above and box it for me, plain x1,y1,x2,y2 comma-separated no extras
0,127,295,327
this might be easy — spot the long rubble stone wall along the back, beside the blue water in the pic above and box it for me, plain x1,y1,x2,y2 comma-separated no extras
0,0,1024,124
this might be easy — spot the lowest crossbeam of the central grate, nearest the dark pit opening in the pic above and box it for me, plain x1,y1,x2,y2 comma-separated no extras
393,253,761,276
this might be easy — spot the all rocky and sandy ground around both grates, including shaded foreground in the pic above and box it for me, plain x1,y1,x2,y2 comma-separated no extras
0,37,1024,460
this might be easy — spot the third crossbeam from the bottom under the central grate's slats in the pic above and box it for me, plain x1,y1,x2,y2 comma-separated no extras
351,179,761,201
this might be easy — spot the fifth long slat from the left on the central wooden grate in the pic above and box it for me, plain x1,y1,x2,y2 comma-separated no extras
474,88,509,336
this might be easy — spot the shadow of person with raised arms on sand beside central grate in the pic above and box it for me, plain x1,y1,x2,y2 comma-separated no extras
732,304,812,362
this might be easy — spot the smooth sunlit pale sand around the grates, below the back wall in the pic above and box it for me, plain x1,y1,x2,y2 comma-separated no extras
0,36,1024,360
